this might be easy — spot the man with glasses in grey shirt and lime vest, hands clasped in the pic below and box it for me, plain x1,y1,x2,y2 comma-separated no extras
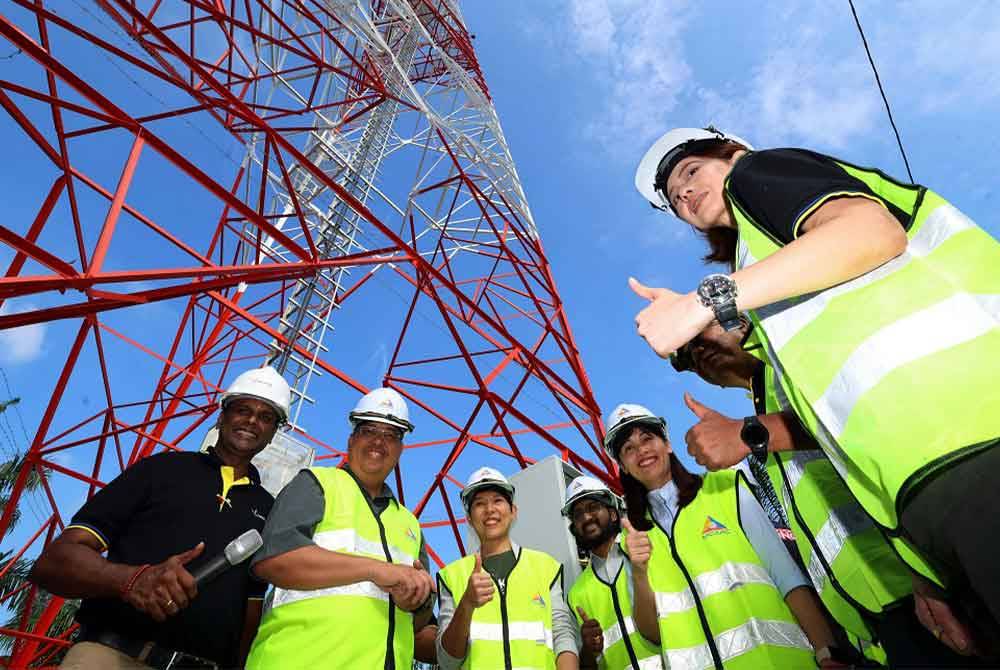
247,388,434,670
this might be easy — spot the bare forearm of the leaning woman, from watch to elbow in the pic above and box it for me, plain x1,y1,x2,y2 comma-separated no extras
732,199,906,311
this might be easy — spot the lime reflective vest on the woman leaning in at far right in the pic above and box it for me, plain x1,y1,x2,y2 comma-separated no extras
725,156,1000,532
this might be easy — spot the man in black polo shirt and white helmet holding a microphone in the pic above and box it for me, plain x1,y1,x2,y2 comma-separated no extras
31,367,290,669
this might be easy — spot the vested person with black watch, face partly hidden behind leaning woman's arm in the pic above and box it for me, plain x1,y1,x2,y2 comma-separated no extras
671,317,988,668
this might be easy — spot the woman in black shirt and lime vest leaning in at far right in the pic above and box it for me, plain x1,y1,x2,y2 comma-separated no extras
632,128,1000,648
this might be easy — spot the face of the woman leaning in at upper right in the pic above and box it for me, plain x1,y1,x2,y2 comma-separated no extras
667,151,745,231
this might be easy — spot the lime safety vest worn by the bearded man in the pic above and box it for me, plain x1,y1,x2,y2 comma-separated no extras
568,557,663,670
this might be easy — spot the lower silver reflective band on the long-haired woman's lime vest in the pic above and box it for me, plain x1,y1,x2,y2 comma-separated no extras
664,619,812,670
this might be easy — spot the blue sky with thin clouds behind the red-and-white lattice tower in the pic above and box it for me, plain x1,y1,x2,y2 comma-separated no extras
0,0,1000,568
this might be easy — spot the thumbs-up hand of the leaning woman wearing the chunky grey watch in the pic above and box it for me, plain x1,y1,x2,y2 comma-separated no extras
628,277,715,358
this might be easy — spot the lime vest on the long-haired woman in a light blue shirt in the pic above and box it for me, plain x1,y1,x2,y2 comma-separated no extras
628,470,815,670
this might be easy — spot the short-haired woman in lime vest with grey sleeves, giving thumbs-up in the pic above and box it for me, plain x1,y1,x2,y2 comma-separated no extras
437,467,578,670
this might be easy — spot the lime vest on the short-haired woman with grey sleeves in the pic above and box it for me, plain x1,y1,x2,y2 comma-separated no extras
438,547,562,670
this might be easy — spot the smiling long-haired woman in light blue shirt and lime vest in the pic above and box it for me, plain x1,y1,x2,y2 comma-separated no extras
604,404,835,670
